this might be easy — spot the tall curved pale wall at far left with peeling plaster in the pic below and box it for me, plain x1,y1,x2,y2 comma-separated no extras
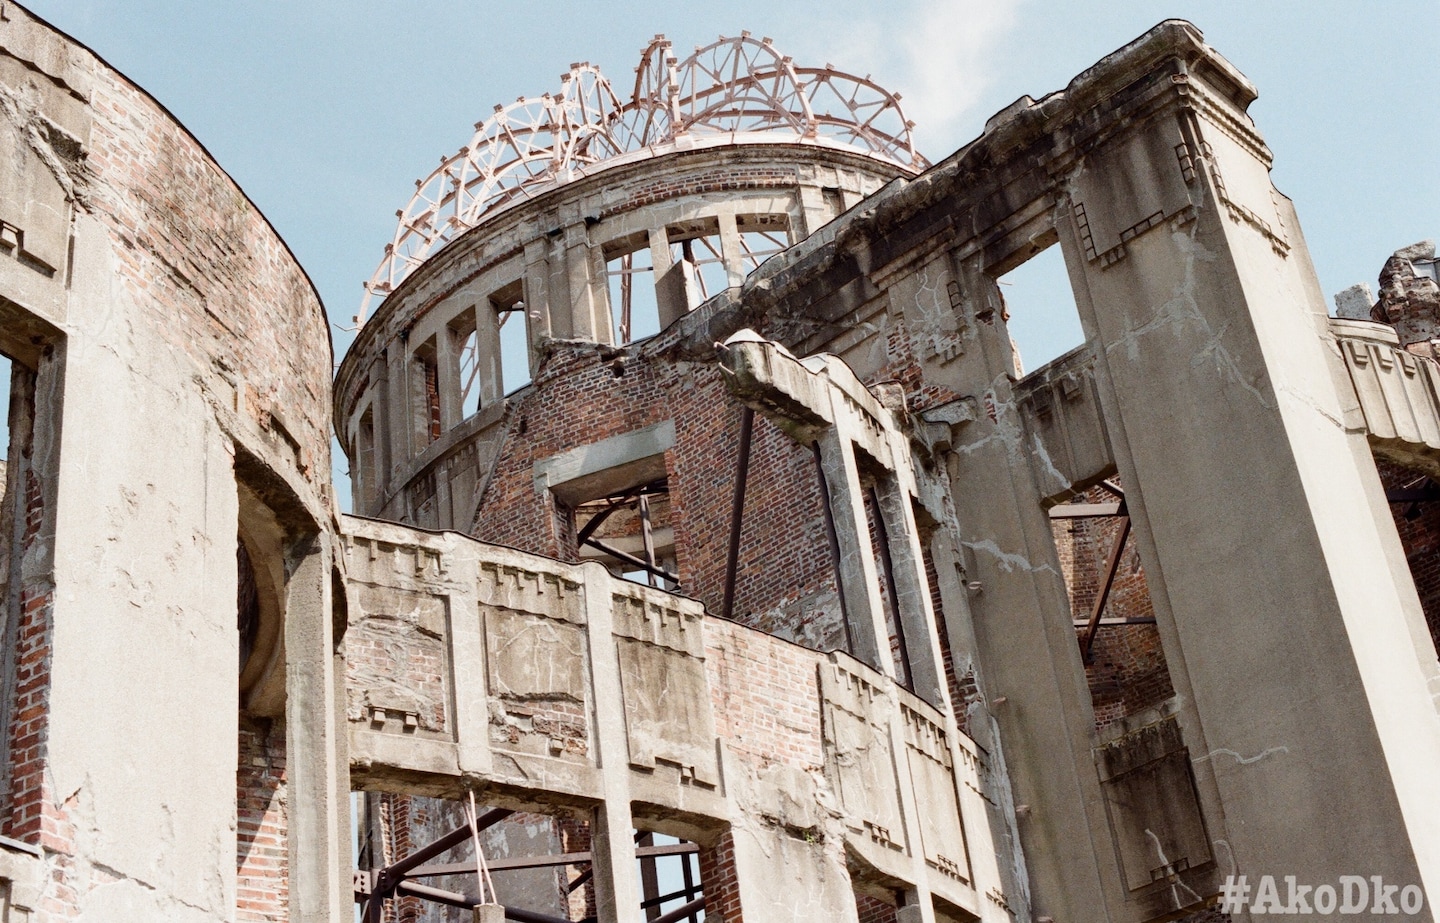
0,3,343,920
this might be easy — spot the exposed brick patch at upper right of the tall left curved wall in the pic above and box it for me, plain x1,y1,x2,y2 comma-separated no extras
81,62,330,515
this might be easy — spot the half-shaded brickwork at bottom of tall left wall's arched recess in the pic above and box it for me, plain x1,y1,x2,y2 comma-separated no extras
235,716,289,923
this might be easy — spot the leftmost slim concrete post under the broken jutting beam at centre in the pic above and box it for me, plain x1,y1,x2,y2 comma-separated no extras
819,426,896,680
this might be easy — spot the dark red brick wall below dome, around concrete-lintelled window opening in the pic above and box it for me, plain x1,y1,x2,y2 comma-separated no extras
472,346,844,649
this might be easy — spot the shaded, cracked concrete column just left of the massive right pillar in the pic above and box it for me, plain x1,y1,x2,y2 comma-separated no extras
930,255,1125,920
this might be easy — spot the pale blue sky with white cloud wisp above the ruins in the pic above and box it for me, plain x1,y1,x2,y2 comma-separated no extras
16,0,1440,506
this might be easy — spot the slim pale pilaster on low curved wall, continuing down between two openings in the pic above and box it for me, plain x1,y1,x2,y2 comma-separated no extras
585,563,639,923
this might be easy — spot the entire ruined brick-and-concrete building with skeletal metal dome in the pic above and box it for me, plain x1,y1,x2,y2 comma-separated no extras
0,3,1440,923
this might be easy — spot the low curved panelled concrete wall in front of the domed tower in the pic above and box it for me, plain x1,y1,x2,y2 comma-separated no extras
346,518,1002,922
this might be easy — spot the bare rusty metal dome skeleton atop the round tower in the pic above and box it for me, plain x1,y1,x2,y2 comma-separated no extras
356,32,929,324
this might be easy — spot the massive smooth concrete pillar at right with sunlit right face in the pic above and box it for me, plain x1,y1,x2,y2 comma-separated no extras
1061,97,1440,919
